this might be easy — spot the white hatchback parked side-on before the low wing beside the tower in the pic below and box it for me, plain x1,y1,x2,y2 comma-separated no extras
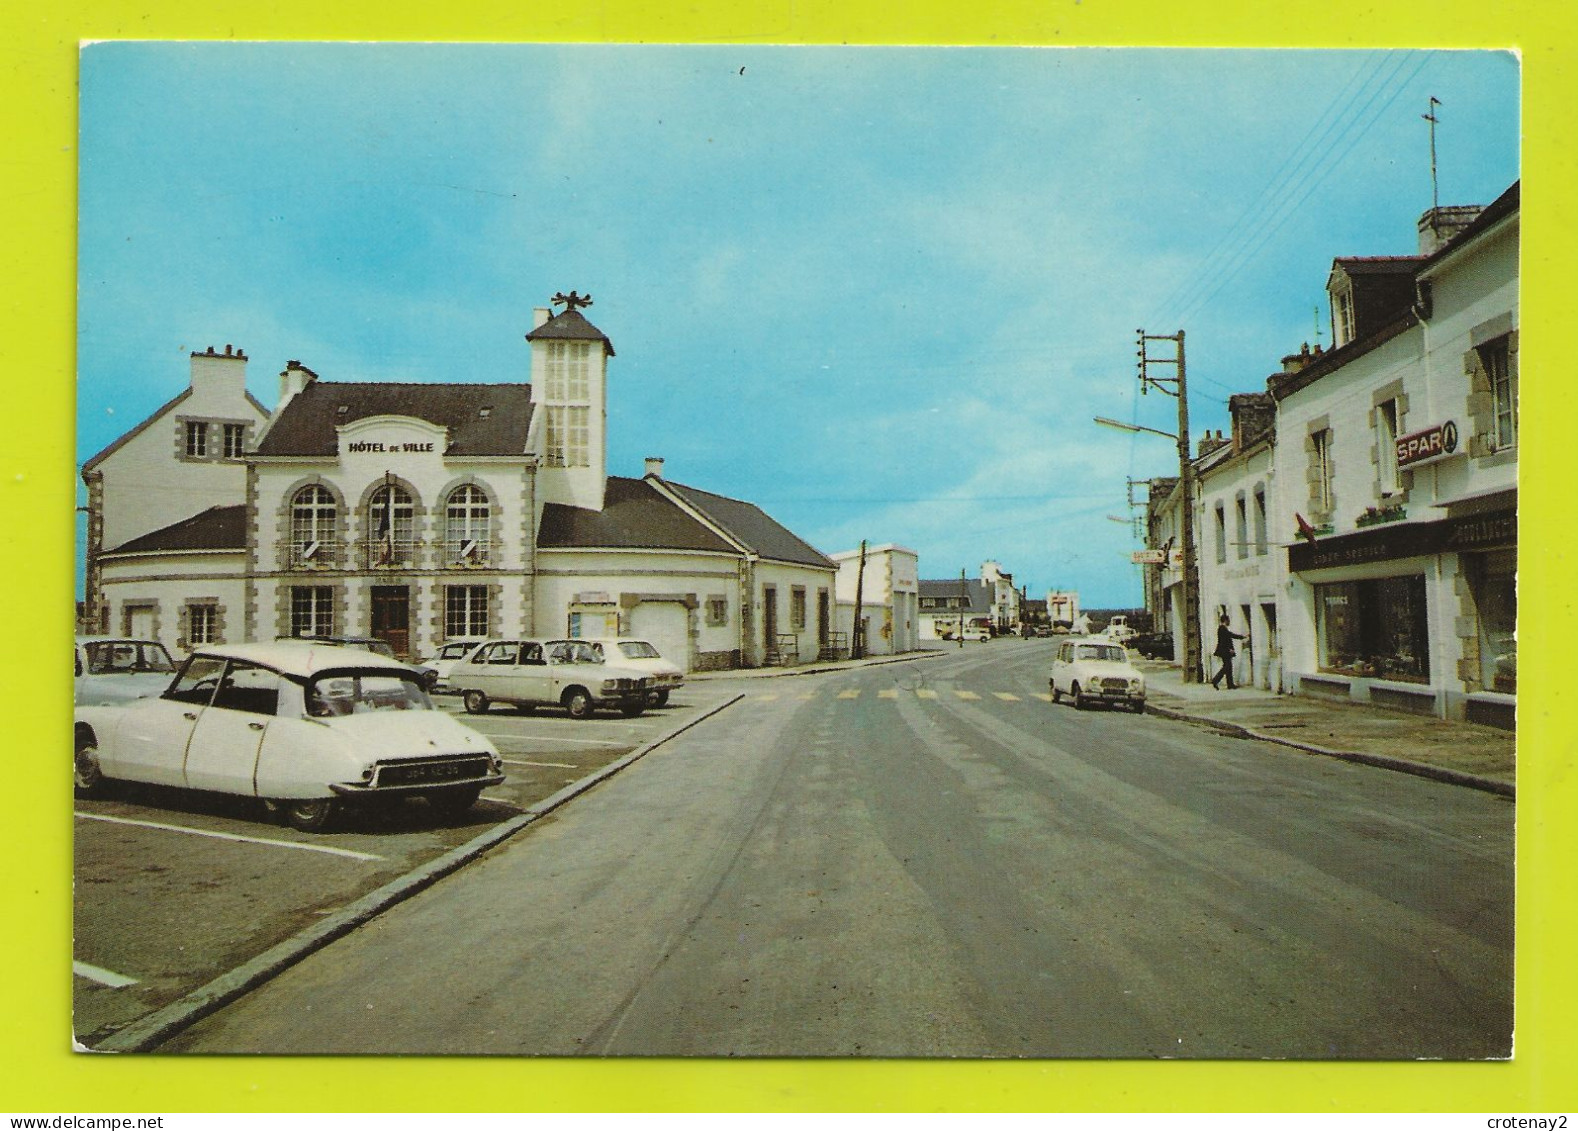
450,639,653,719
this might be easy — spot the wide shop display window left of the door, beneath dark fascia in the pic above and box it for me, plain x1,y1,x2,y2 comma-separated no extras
1314,574,1430,683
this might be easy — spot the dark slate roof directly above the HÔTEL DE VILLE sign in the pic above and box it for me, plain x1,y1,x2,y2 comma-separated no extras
257,380,532,456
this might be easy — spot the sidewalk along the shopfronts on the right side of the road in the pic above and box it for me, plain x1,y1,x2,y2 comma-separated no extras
1139,661,1516,797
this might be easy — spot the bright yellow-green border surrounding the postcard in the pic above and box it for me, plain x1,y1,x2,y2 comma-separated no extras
0,0,1578,1114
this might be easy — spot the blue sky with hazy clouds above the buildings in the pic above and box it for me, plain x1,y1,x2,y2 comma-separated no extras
77,43,1520,607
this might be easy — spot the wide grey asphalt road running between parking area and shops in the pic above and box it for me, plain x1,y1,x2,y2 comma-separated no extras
163,640,1513,1058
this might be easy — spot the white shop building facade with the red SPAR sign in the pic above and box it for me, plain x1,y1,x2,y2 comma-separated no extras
1275,191,1518,726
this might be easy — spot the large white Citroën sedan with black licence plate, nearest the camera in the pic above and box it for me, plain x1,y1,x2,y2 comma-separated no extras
74,640,503,830
